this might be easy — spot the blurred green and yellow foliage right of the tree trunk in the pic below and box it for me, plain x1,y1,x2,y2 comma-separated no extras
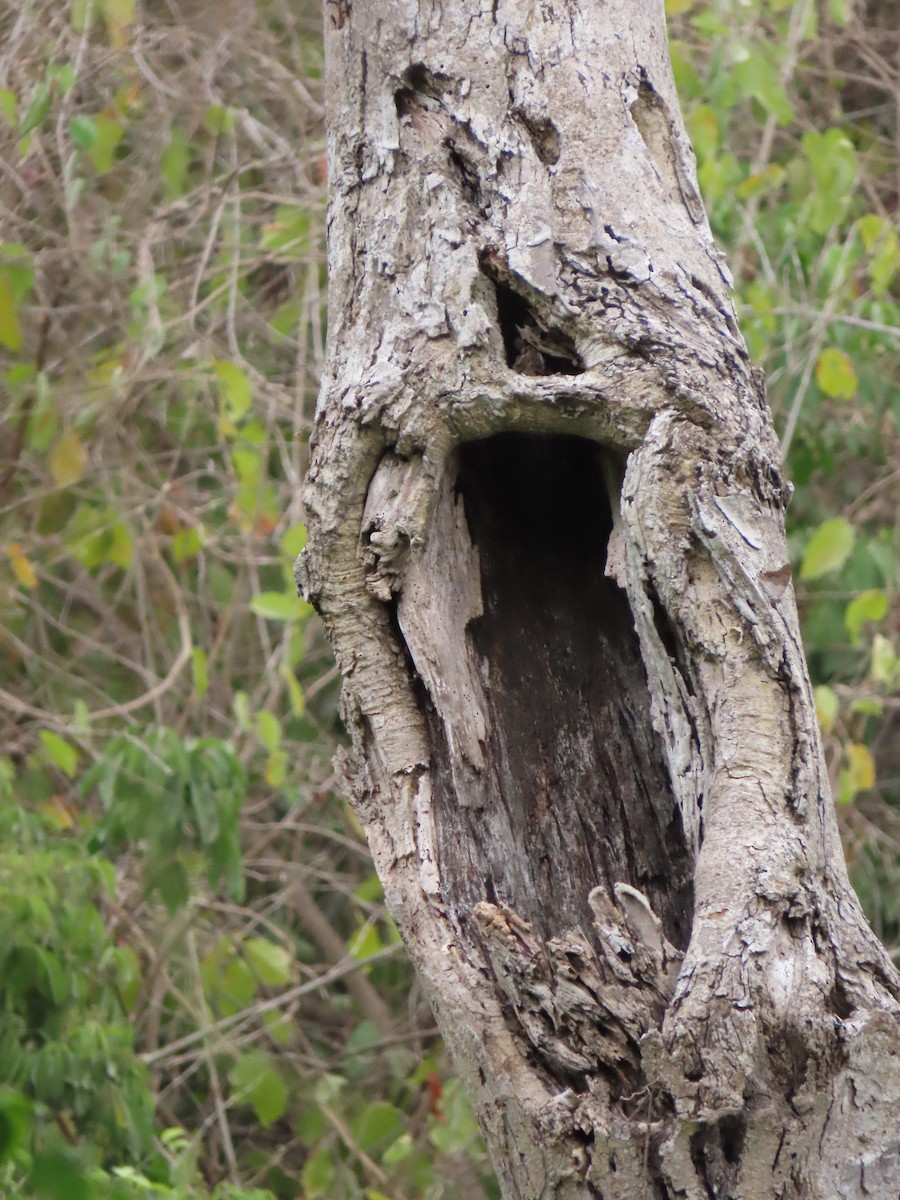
667,0,900,949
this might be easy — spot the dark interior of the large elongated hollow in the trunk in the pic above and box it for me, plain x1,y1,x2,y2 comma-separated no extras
426,433,692,947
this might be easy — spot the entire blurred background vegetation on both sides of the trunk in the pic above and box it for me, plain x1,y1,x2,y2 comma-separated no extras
0,0,900,1200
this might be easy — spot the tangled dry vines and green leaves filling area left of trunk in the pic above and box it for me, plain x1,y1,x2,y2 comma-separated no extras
0,0,496,1200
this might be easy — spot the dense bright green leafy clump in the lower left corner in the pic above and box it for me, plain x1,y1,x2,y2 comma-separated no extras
0,797,152,1157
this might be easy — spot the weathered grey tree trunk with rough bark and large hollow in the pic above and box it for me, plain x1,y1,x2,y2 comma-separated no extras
300,0,900,1200
